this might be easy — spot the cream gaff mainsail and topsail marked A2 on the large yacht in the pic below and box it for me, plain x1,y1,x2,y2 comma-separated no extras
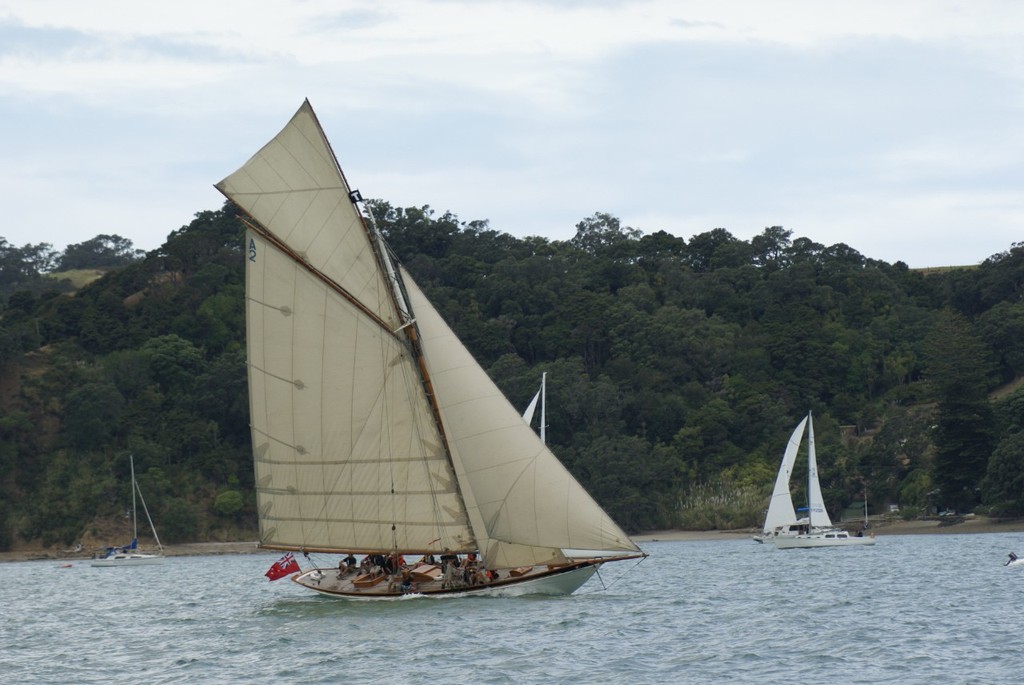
217,102,476,551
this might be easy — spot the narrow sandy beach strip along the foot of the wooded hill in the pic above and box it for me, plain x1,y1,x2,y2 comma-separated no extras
8,516,1024,563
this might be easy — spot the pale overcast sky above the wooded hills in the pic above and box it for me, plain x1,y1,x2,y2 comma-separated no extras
0,0,1024,266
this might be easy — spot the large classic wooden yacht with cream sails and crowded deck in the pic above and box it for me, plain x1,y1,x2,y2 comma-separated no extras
216,100,644,599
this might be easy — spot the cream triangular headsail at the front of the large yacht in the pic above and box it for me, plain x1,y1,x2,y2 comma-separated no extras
402,271,638,566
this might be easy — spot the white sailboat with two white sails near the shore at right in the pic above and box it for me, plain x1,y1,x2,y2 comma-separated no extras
764,413,874,550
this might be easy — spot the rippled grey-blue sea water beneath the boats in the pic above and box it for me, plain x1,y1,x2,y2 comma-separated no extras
0,533,1024,685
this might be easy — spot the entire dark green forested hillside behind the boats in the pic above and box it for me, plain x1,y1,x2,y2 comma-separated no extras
0,202,1024,549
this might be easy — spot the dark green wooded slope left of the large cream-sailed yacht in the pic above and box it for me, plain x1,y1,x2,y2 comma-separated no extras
0,206,252,544
